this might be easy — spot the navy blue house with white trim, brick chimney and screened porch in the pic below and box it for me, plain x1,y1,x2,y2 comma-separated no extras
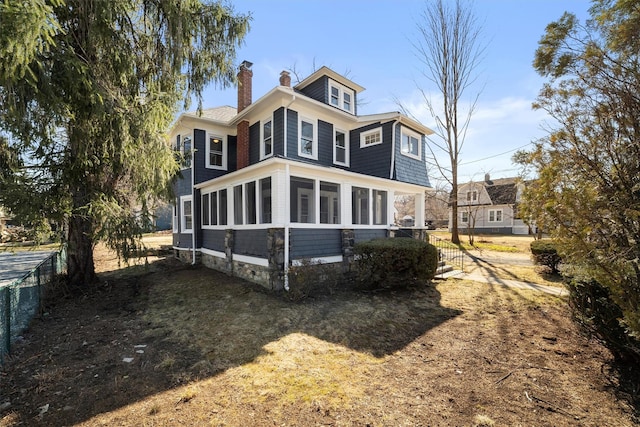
170,61,432,289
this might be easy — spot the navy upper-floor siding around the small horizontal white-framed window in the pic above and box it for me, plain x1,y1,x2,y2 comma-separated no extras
349,123,392,178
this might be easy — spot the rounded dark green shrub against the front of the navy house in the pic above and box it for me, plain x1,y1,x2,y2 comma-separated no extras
354,237,438,290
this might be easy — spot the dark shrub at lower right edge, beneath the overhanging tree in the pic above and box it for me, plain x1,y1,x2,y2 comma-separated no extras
565,277,640,364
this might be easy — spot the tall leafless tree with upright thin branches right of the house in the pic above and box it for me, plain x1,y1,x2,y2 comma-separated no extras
400,0,485,243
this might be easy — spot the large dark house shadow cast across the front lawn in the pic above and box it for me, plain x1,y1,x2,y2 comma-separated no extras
0,259,461,426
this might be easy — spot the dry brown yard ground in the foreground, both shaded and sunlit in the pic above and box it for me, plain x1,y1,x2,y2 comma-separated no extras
0,238,637,427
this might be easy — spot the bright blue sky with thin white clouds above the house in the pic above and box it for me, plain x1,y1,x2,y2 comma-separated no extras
198,0,590,184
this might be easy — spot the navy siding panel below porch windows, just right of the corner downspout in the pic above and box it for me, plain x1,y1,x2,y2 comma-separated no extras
289,228,342,259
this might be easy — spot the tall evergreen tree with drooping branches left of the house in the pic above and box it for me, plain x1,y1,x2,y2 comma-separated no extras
0,0,250,285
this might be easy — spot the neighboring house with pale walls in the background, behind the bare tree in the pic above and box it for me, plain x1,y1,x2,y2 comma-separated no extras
449,174,531,234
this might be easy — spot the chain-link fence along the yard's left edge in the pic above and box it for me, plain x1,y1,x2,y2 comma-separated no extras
0,249,67,365
